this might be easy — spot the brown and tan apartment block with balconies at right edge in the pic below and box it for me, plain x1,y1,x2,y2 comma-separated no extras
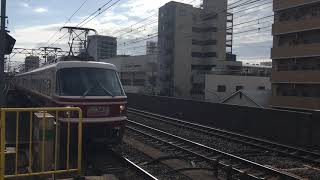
270,0,320,109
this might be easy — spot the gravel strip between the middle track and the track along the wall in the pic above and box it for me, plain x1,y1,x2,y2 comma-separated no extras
129,114,320,179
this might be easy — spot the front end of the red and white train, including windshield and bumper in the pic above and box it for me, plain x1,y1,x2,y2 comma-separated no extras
56,63,127,146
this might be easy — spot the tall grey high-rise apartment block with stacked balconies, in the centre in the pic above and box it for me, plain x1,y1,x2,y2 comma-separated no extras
158,0,241,99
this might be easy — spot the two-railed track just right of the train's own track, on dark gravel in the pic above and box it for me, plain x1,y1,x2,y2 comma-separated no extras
127,120,302,179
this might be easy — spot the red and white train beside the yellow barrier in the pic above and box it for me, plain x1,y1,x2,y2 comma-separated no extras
15,61,127,145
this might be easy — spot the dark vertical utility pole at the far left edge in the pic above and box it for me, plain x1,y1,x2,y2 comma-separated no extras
0,0,6,107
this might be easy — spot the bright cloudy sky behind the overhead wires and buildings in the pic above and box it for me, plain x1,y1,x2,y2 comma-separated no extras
7,0,272,69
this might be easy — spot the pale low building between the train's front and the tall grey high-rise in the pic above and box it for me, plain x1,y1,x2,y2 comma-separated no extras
102,55,158,94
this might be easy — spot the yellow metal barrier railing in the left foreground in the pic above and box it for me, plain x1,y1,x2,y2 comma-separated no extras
0,107,83,180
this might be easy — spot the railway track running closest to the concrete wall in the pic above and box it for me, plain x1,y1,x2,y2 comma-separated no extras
128,108,320,164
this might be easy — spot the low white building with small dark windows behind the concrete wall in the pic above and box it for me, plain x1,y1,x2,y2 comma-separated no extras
205,74,271,103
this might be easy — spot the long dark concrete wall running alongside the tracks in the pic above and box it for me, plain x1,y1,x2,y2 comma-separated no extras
128,94,320,147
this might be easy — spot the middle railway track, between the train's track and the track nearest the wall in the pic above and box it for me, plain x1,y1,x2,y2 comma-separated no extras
127,120,301,180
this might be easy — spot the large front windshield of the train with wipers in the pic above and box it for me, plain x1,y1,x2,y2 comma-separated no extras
57,68,125,97
